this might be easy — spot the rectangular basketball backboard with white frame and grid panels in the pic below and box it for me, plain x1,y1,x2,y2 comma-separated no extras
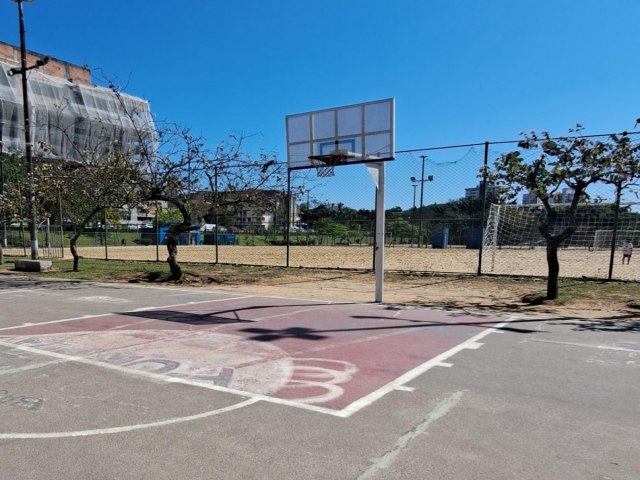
286,98,395,170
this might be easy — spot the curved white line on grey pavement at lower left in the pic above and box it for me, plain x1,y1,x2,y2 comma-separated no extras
0,398,258,440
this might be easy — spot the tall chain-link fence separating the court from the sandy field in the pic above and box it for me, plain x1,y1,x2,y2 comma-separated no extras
7,131,640,280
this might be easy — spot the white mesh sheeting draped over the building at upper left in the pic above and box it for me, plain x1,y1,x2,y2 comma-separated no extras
0,63,154,161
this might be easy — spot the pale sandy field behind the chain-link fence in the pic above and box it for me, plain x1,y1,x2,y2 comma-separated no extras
16,245,640,280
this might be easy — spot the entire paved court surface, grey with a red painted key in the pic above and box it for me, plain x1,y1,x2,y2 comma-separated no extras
0,276,640,479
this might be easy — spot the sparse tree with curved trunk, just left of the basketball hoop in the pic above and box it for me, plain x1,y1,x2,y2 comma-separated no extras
109,83,286,280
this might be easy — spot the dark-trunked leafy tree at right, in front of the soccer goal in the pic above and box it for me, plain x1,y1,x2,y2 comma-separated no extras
488,125,640,300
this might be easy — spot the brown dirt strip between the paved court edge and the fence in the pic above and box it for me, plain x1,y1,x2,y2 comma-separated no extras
109,266,640,329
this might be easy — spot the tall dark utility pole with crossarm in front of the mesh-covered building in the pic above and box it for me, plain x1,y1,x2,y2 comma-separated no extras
7,0,49,260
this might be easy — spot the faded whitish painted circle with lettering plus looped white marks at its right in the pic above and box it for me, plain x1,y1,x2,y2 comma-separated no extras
1,329,358,404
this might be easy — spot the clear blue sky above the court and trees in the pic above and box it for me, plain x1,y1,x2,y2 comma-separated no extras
0,0,640,207
